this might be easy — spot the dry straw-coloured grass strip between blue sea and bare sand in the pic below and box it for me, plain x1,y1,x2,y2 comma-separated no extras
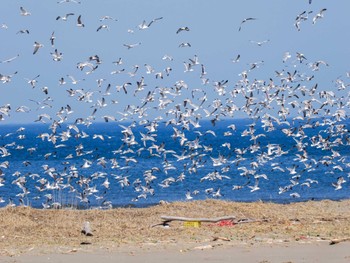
0,200,350,254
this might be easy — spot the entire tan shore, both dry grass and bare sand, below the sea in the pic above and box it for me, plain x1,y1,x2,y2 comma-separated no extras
0,200,350,262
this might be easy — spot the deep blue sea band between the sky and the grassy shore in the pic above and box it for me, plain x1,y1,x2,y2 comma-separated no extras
0,119,350,209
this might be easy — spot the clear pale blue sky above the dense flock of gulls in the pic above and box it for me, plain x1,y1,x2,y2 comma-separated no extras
0,0,350,124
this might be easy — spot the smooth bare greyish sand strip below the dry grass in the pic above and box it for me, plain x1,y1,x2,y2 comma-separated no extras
4,242,350,263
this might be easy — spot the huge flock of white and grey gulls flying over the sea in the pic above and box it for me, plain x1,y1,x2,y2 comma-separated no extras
0,0,350,208
